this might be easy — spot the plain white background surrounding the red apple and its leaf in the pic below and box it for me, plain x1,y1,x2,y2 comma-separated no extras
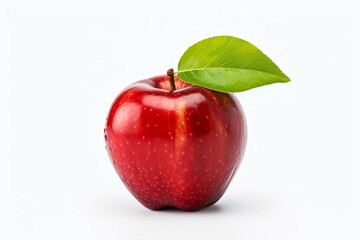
0,0,360,240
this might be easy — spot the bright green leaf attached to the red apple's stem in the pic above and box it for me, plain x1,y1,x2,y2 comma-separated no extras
177,36,290,92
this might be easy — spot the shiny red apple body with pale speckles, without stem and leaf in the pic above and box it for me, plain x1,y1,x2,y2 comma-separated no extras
104,76,247,211
